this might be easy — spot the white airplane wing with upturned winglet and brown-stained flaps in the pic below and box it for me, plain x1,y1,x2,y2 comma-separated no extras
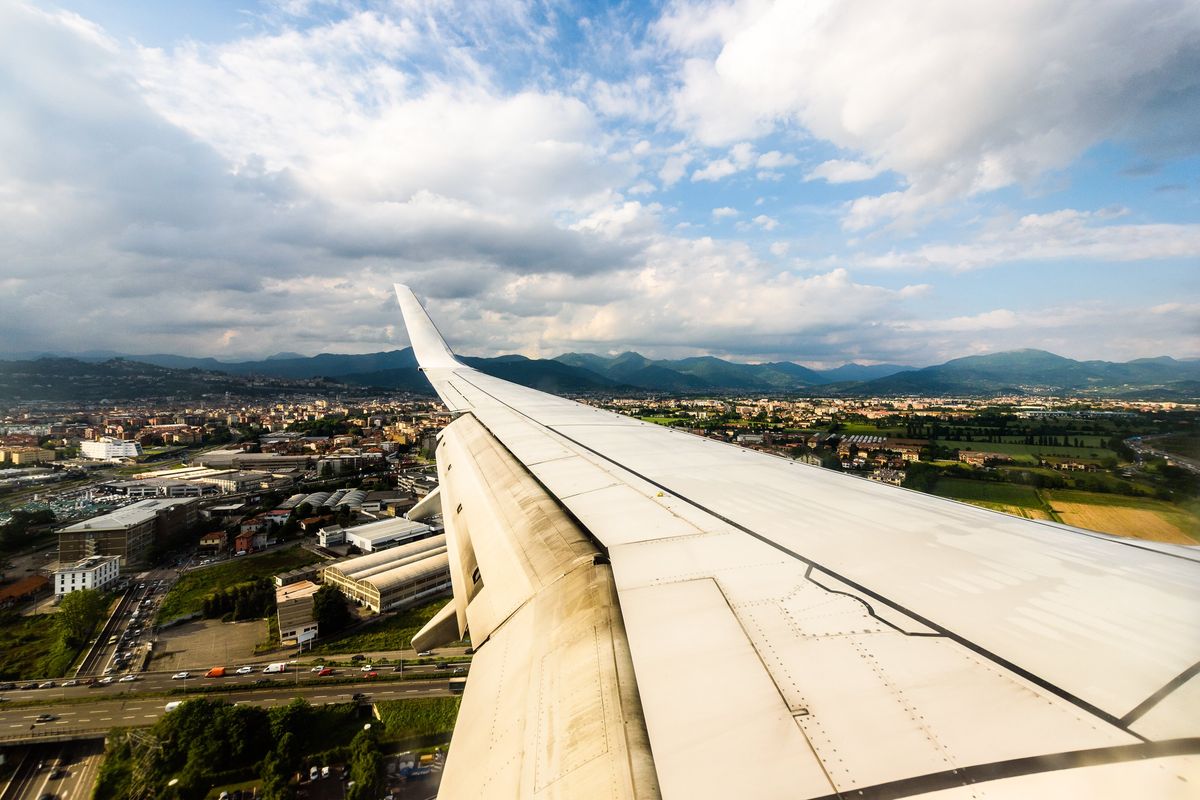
396,284,1200,800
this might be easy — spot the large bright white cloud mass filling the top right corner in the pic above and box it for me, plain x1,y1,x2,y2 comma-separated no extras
658,0,1200,230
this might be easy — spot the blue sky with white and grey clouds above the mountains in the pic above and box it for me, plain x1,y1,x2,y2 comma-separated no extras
0,0,1200,367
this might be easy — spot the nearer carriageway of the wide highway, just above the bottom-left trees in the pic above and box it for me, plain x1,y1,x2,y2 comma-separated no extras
0,681,450,741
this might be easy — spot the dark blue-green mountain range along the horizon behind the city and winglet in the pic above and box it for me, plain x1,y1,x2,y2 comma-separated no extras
0,348,1200,399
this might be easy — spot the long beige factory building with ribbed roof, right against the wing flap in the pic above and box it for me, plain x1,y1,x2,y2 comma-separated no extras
322,534,450,612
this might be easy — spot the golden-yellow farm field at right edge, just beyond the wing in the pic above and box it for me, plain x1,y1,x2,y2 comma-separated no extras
1043,489,1200,545
